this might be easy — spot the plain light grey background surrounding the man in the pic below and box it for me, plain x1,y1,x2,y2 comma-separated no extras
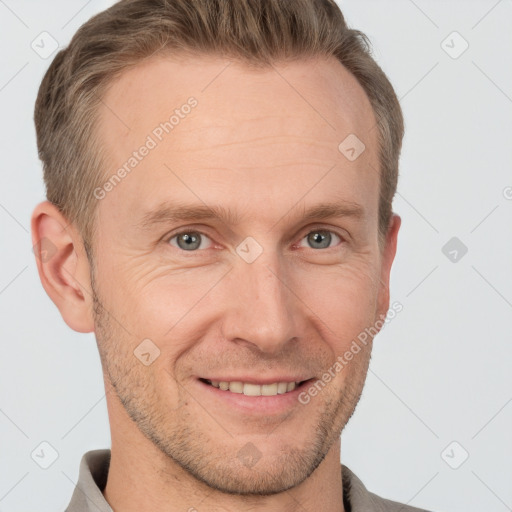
0,0,512,512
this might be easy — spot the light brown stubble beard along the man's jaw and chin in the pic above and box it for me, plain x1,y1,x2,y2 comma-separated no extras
92,282,371,500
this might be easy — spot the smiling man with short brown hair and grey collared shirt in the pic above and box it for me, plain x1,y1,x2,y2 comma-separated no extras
32,0,432,512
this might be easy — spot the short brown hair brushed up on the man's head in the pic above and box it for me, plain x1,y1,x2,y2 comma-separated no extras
34,0,404,254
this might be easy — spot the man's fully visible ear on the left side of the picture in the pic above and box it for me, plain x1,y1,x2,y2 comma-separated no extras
31,201,94,332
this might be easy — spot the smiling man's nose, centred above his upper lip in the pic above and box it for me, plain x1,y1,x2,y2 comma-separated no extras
222,251,305,354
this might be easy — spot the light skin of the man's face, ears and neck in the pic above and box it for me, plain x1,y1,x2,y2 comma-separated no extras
32,56,400,512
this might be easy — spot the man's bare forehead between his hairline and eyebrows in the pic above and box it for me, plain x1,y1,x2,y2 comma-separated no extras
98,56,379,227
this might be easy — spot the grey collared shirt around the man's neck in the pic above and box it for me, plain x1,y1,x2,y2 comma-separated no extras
66,449,428,512
